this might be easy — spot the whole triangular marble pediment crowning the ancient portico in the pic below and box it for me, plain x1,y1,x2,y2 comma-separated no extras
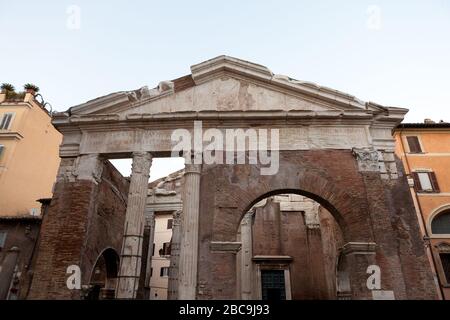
69,56,402,116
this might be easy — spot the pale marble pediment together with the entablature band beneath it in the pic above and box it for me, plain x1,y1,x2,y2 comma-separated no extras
53,56,407,170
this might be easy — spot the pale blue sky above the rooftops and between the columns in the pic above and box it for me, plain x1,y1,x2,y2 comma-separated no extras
0,0,450,180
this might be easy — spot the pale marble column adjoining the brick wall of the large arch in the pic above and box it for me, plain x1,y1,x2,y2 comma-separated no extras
178,164,201,300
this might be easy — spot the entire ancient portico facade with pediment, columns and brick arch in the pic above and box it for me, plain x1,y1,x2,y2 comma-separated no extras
25,56,437,300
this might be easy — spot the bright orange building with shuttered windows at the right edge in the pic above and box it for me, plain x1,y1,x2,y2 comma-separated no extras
394,120,450,300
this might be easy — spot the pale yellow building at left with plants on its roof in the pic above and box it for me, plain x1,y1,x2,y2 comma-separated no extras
0,91,62,216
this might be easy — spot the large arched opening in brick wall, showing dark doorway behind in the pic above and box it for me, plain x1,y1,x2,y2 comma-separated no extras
237,190,351,300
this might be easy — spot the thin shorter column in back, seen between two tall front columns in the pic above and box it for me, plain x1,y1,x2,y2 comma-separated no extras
168,210,182,300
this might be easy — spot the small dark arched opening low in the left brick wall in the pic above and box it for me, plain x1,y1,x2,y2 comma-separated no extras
87,248,119,300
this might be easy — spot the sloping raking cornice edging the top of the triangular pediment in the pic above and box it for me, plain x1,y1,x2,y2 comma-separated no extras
57,56,407,122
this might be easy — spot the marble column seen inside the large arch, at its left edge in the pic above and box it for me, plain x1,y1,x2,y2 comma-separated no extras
241,211,254,300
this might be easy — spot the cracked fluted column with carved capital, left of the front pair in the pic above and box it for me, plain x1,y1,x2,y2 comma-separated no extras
116,152,152,299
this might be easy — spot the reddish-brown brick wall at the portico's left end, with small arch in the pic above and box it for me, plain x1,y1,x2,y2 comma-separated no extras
29,161,129,299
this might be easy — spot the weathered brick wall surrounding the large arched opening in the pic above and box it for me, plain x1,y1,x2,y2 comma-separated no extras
197,150,436,299
